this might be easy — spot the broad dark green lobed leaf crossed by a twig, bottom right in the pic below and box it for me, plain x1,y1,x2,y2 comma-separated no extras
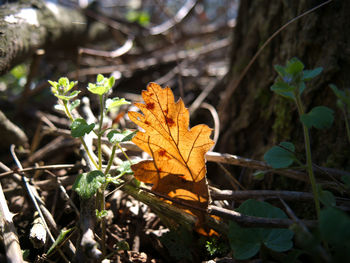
228,199,294,260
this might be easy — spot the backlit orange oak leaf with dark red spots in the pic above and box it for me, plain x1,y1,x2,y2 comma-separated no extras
129,83,214,235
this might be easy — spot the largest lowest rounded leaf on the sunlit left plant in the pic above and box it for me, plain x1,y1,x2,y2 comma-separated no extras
73,170,106,199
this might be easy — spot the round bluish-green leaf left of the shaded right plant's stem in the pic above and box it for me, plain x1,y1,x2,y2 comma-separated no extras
264,142,296,169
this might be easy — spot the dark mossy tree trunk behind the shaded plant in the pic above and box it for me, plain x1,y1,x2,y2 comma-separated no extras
217,0,350,173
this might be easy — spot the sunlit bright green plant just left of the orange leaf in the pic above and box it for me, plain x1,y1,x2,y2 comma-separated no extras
49,74,135,255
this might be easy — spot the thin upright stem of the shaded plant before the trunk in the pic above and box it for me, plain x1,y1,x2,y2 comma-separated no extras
294,91,321,219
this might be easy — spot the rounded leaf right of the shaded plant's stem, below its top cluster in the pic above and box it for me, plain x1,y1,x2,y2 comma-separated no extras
300,106,334,129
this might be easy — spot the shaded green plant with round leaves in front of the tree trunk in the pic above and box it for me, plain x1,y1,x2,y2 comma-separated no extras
264,58,334,221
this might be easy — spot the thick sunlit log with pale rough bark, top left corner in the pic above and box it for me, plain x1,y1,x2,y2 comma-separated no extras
0,0,107,75
